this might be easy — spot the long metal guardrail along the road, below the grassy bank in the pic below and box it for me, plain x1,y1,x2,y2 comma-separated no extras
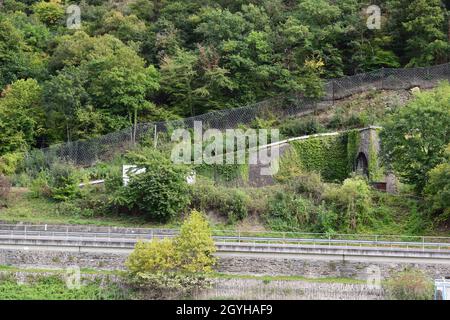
0,225,450,251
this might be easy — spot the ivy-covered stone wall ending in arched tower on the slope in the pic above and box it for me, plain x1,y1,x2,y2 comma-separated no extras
195,128,384,185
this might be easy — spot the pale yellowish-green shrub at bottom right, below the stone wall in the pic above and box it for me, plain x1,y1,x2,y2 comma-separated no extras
384,270,434,300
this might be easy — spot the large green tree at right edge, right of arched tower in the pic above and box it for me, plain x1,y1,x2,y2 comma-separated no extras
381,83,450,192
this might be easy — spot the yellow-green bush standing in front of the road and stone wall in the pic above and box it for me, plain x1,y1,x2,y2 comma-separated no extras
126,211,216,298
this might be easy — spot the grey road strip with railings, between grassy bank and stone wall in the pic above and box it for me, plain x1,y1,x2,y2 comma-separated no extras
0,225,450,264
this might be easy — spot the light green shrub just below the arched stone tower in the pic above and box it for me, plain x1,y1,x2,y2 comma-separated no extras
323,177,372,231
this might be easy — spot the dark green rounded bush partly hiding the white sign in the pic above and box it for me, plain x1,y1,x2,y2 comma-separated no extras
113,149,190,221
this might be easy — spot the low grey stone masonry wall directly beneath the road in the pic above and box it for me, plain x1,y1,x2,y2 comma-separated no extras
0,249,450,279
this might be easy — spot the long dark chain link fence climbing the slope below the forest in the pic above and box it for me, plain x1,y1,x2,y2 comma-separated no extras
27,63,450,166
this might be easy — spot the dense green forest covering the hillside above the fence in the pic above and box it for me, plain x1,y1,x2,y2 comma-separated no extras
0,0,449,158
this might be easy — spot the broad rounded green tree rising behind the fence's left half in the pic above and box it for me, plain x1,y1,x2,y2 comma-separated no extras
44,31,159,140
